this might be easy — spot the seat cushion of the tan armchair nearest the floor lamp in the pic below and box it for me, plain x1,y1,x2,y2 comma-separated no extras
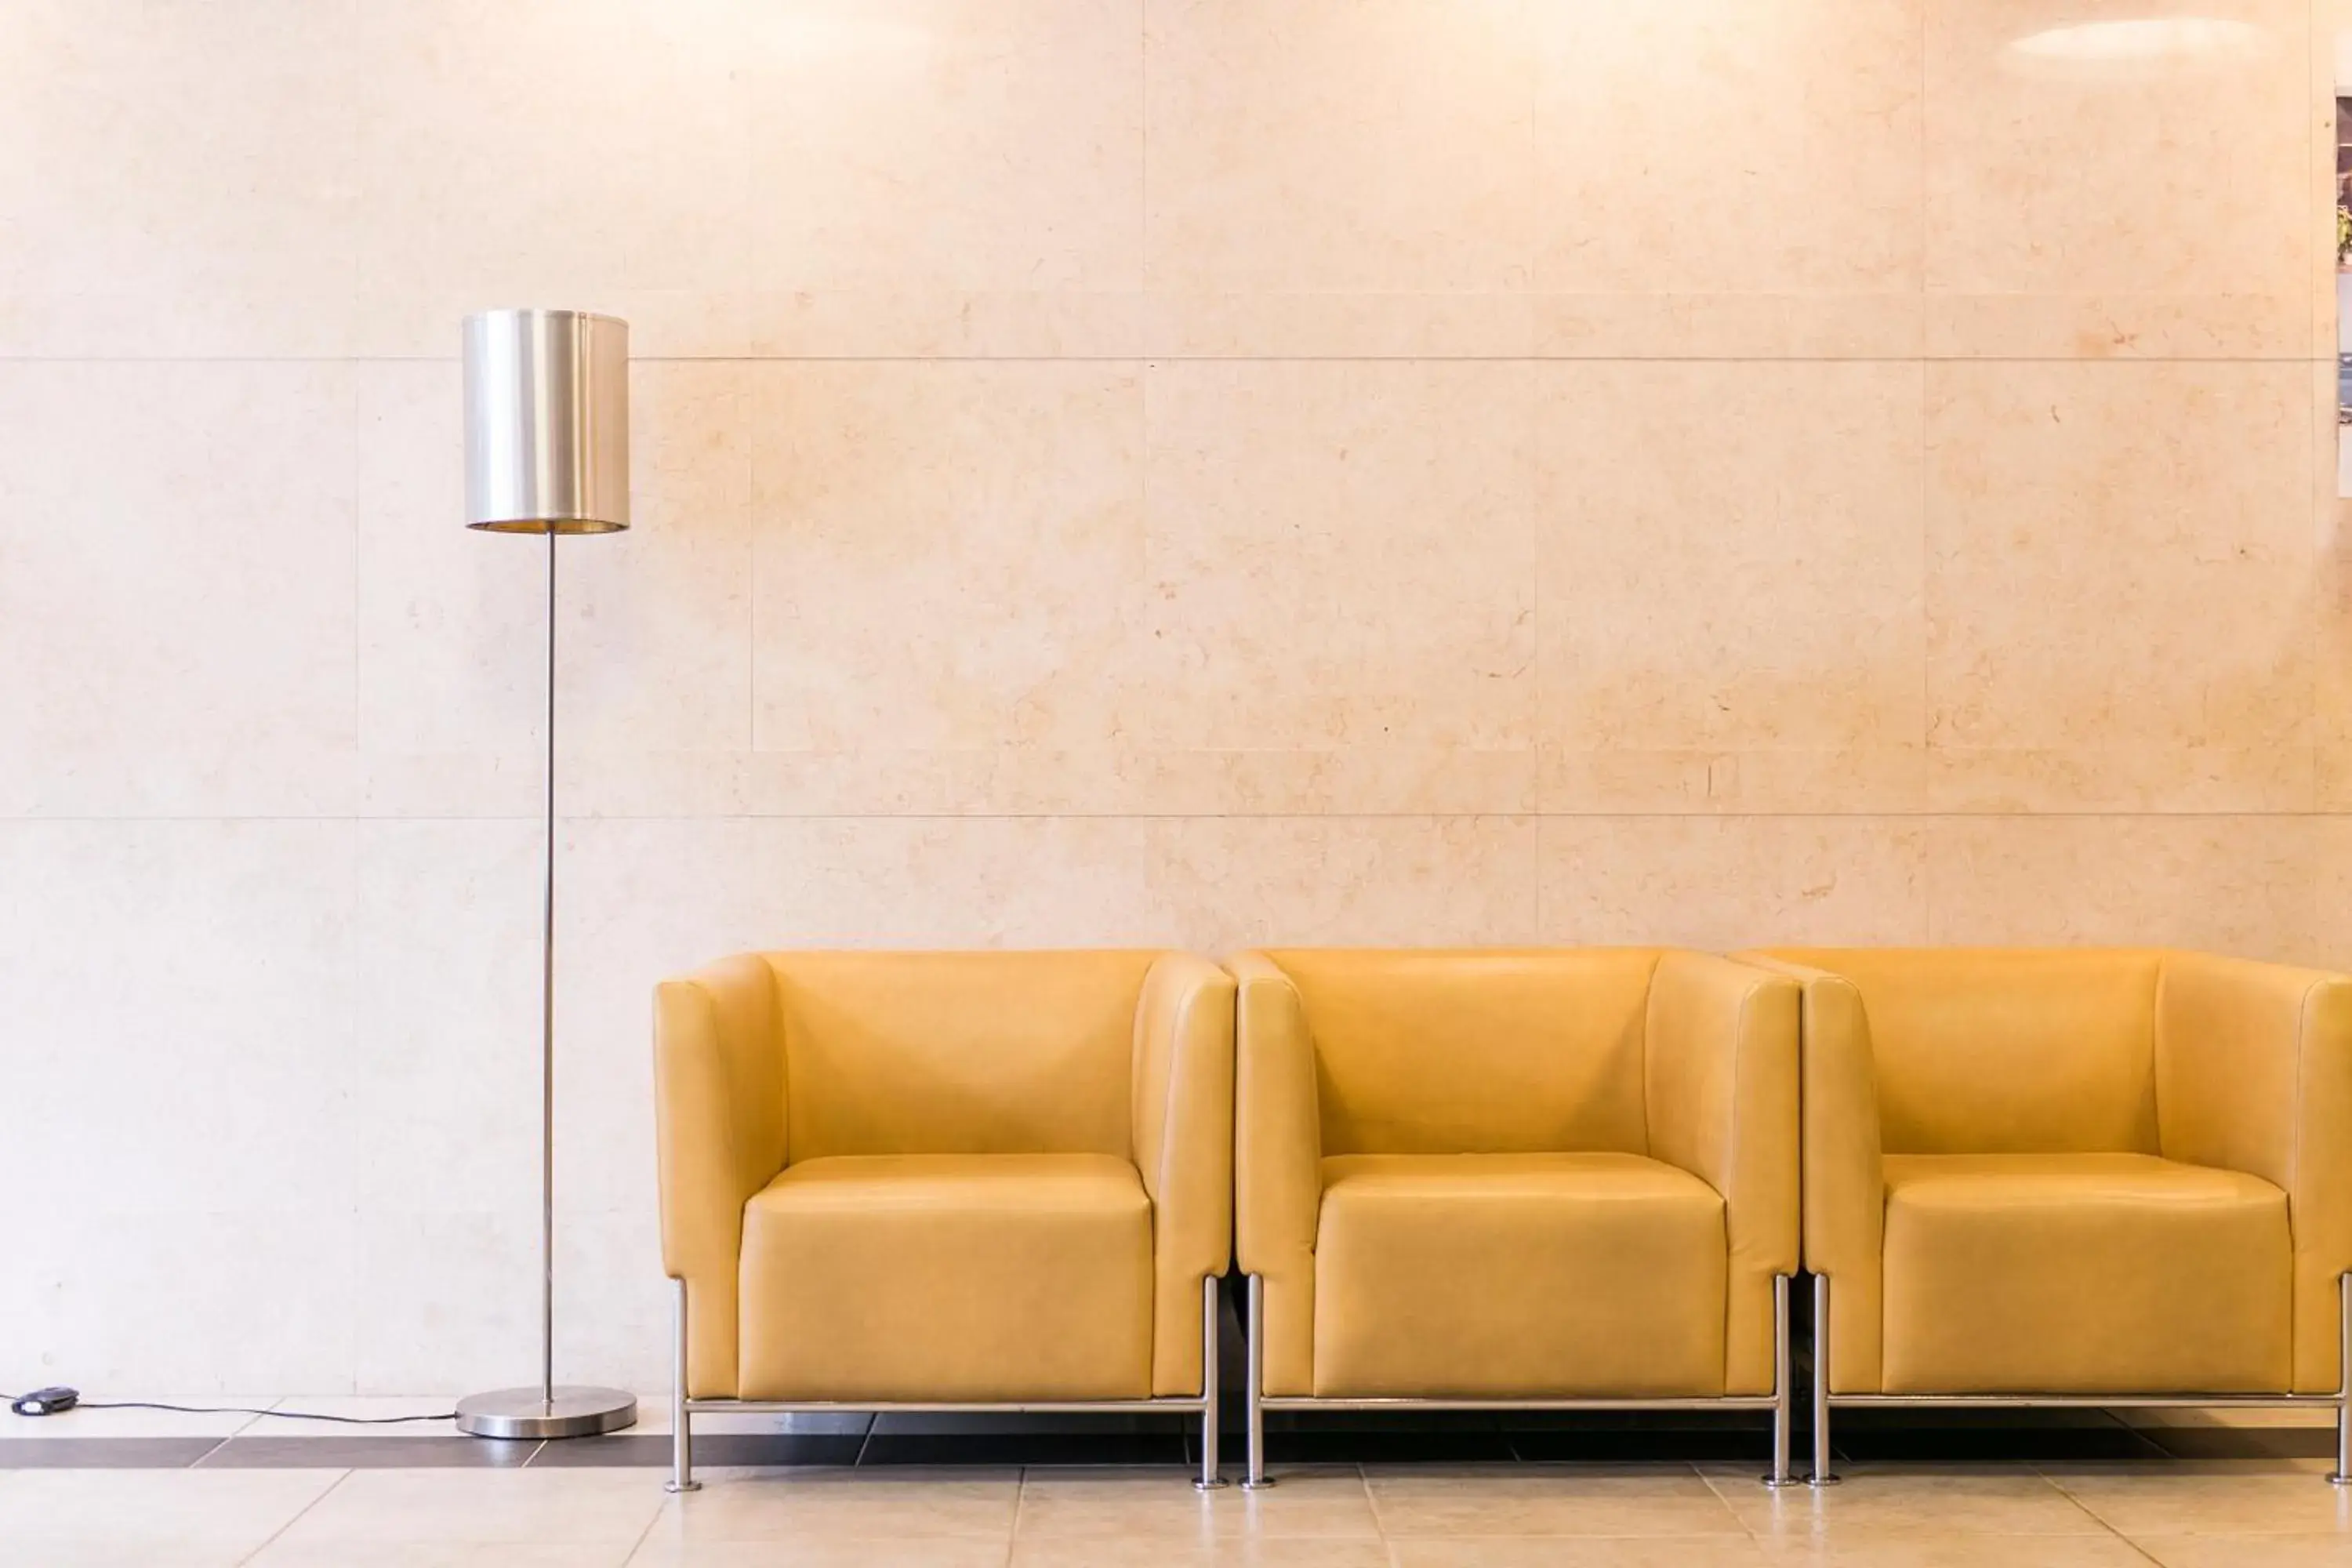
741,1154,1152,1403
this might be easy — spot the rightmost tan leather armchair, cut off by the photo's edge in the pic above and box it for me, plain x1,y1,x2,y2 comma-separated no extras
1745,947,2352,1479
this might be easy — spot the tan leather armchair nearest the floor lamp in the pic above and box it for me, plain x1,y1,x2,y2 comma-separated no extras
654,952,1232,1488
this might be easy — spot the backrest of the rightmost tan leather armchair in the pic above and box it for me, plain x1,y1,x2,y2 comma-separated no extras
1771,947,2164,1154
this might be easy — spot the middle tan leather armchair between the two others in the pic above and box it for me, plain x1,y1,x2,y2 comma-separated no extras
1228,947,1797,1486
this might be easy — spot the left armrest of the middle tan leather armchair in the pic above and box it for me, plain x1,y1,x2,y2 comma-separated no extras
1225,952,1322,1394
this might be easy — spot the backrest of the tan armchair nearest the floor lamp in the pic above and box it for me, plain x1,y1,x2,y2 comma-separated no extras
767,952,1160,1163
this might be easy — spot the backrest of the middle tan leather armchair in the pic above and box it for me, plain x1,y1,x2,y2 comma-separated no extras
1265,947,1658,1154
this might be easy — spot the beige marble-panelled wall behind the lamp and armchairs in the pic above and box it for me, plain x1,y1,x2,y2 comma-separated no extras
0,0,2352,1392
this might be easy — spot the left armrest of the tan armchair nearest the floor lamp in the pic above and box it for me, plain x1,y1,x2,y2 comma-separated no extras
654,954,786,1396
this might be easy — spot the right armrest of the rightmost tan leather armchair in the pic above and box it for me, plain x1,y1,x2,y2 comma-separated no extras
2157,952,2352,1394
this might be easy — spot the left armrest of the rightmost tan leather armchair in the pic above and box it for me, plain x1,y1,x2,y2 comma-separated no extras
1733,952,1886,1394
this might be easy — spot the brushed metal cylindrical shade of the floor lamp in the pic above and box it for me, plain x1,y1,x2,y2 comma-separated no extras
466,310,628,534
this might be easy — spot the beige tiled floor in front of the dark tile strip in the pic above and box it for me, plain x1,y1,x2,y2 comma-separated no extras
0,1460,2352,1568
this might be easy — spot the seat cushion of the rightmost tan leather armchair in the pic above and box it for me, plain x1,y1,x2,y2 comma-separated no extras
1884,1154,2293,1394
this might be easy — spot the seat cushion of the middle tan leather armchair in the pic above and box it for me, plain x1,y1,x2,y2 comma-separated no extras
1315,1154,1726,1399
